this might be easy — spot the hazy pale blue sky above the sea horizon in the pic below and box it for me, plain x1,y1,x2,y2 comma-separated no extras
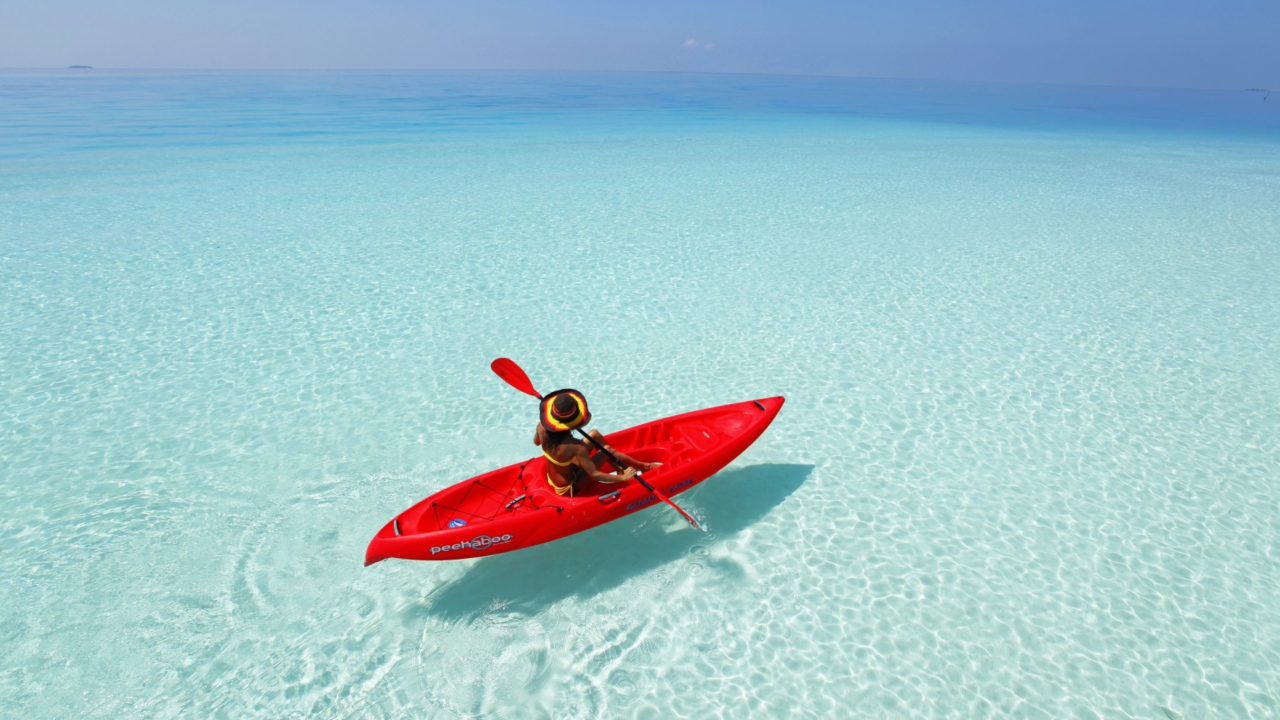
0,0,1280,90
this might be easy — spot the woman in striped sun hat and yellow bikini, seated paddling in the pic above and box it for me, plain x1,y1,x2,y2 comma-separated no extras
534,389,658,497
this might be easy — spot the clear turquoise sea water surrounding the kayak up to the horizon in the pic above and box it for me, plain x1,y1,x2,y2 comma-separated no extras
0,73,1280,719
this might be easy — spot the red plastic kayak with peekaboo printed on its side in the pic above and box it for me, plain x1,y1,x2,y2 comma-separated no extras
365,397,783,565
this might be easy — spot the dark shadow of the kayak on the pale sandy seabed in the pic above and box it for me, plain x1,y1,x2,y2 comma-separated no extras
411,465,814,620
